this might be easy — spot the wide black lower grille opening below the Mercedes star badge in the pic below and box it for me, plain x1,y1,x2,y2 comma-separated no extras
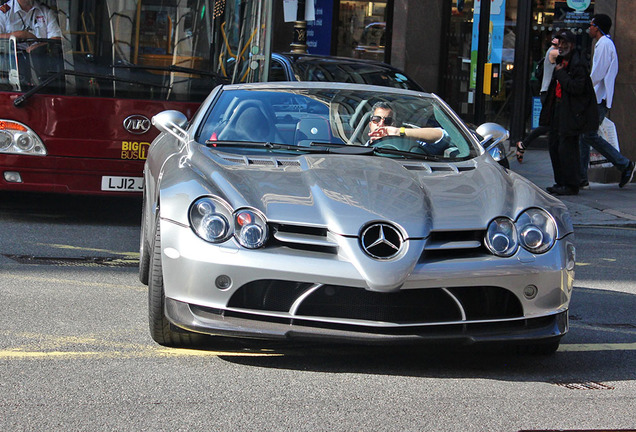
228,280,523,325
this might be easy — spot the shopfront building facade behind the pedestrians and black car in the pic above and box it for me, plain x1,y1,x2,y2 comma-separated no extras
274,0,636,181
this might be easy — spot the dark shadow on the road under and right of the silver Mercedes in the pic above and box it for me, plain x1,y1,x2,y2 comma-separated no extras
186,288,636,383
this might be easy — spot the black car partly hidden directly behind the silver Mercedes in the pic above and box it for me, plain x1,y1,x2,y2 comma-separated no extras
269,53,424,91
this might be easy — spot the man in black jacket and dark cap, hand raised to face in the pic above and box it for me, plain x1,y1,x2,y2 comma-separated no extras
547,30,599,195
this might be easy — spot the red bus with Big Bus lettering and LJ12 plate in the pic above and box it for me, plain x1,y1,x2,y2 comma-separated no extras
0,0,271,194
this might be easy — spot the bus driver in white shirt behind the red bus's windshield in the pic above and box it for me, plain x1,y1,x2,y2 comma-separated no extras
0,0,62,51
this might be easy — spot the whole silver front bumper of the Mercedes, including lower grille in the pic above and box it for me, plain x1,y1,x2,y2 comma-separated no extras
161,220,574,343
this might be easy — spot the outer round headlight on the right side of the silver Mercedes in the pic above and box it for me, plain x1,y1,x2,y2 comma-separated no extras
516,208,557,254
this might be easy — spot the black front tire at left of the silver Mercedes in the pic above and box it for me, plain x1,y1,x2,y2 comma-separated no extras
148,217,205,347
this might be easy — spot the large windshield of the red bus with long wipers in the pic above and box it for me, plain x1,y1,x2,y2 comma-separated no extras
0,0,265,101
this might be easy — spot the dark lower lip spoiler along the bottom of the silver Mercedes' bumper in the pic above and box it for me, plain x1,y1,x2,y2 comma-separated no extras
165,298,568,344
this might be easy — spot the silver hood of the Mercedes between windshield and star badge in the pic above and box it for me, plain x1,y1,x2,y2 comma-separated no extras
186,149,558,238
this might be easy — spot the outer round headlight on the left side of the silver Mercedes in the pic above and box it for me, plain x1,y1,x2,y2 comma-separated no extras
190,197,232,243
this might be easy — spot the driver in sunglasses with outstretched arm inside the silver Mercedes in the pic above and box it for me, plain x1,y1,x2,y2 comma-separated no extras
367,102,446,146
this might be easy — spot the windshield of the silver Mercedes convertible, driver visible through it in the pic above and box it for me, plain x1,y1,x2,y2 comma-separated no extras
196,88,479,160
